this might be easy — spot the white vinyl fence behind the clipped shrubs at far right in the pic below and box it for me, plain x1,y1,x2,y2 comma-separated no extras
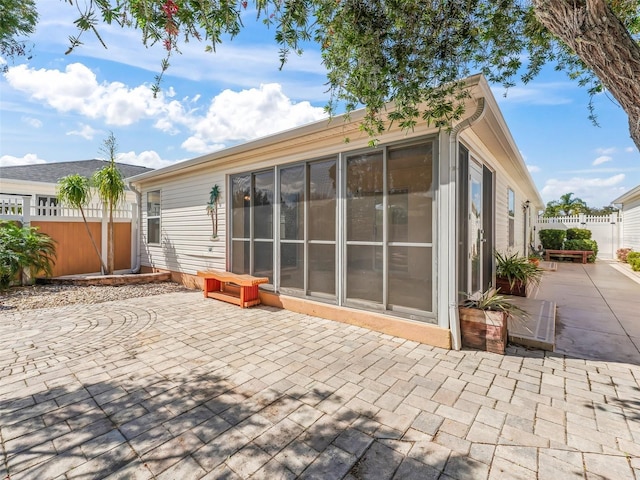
535,213,622,259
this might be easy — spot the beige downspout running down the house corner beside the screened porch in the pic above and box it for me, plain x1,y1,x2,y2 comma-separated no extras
448,97,485,350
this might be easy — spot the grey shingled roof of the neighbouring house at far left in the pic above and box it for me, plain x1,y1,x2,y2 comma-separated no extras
0,159,153,183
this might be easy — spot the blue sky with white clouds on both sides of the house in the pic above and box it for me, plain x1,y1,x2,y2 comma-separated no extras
0,2,640,207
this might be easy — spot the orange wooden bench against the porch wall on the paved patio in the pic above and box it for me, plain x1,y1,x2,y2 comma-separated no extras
198,270,269,308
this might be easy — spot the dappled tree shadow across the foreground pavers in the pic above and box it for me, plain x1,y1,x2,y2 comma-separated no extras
0,362,480,480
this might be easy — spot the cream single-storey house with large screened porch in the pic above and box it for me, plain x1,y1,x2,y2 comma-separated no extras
128,76,543,348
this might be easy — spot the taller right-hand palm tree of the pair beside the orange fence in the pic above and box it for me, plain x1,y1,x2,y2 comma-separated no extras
93,132,125,275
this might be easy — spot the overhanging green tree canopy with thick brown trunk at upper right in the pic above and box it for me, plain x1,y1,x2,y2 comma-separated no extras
1,0,640,149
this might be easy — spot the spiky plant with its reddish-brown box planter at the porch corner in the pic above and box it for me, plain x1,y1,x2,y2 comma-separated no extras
458,288,526,355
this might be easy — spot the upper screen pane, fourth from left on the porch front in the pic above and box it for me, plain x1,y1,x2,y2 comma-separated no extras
308,160,336,241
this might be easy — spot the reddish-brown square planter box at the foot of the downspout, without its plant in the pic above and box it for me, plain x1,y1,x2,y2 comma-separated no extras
458,307,507,355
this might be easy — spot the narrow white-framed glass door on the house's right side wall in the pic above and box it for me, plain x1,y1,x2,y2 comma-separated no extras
467,161,484,295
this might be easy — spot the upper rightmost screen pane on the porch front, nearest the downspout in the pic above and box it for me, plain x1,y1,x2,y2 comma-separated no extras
387,143,433,243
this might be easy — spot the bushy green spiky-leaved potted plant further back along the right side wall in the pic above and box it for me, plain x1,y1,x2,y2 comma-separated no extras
495,252,543,297
